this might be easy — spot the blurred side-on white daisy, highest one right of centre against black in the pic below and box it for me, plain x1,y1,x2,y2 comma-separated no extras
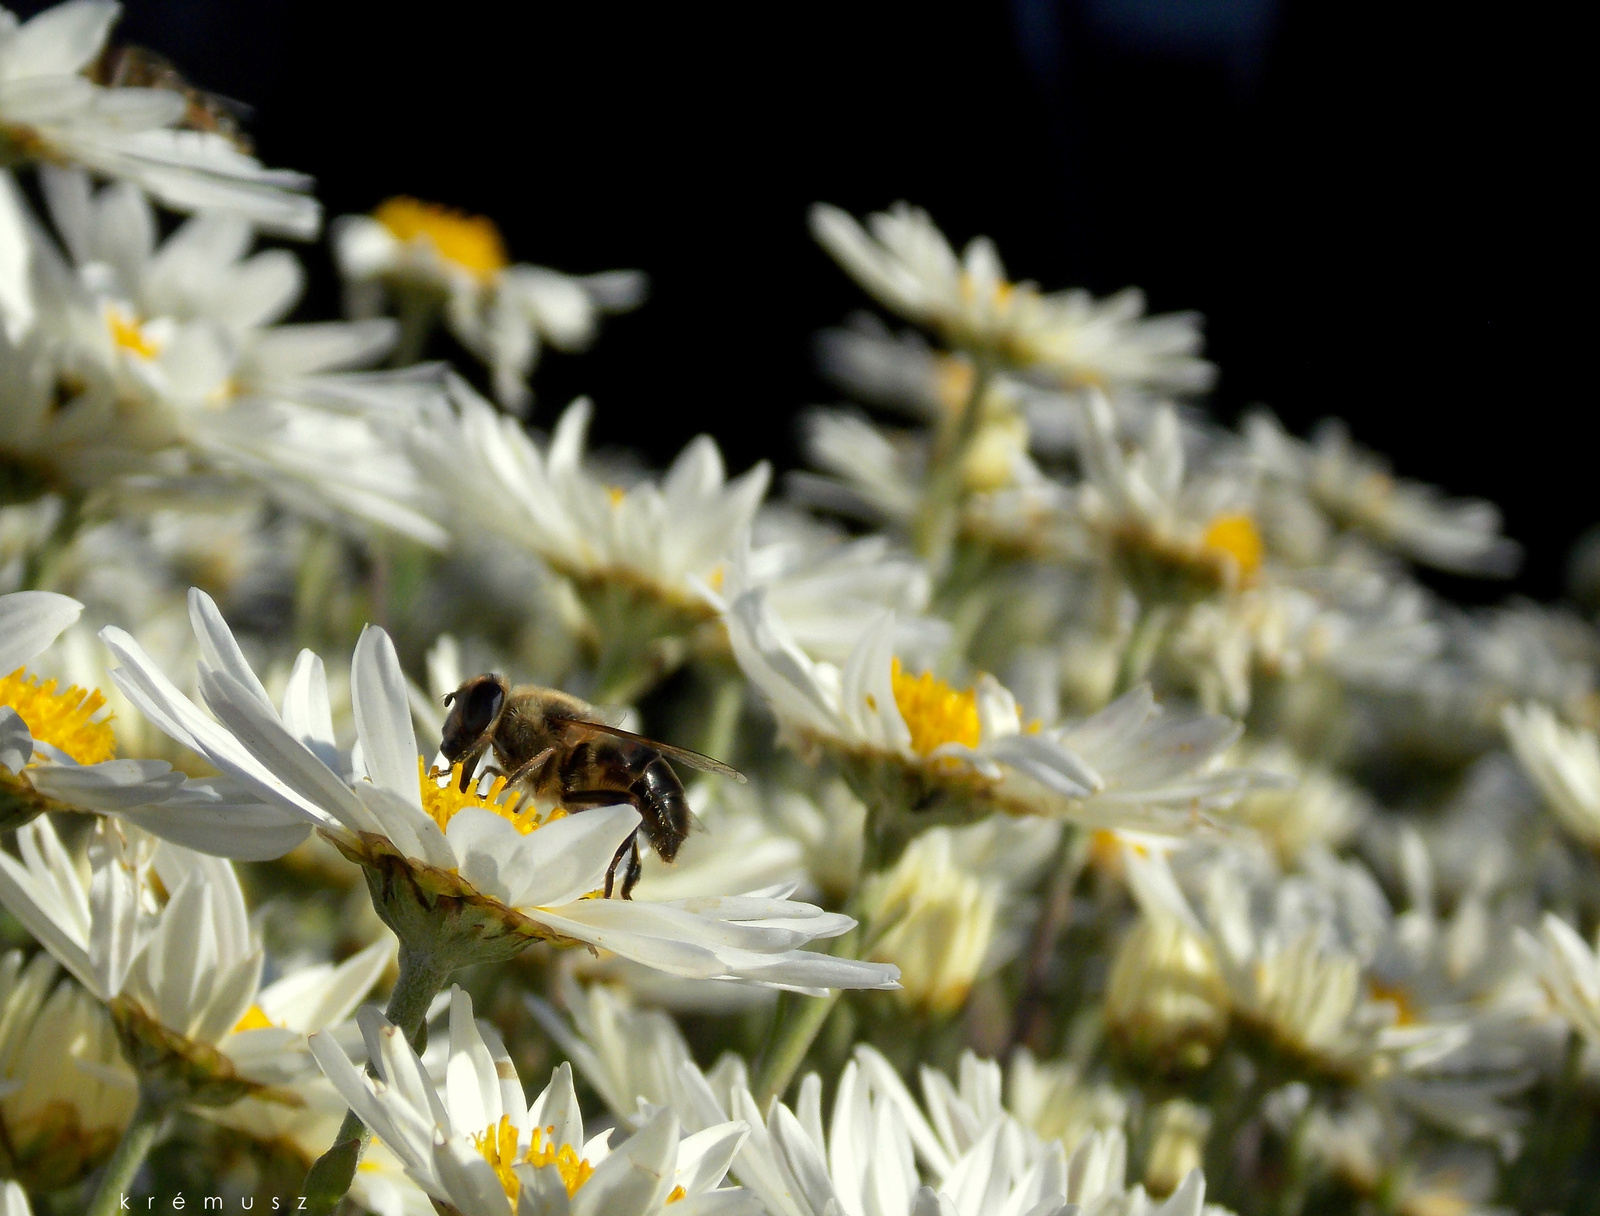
811,203,1214,392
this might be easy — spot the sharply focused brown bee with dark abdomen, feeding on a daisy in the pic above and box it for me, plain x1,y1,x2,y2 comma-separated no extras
438,675,744,899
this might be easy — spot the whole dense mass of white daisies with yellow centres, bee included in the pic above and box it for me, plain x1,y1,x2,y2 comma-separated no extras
0,9,1600,1216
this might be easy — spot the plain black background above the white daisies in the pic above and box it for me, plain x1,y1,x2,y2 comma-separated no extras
21,0,1600,598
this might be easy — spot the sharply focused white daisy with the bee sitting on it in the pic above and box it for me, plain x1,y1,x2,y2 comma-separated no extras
102,590,894,990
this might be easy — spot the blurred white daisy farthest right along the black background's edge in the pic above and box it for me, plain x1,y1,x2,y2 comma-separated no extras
1245,414,1522,578
